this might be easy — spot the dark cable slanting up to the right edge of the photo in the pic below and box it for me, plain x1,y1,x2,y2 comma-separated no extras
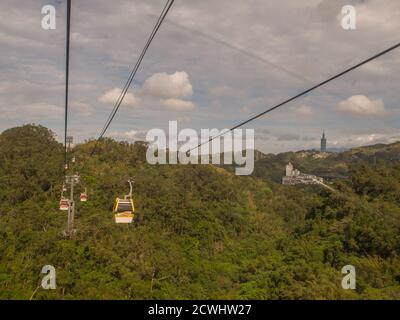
188,43,400,153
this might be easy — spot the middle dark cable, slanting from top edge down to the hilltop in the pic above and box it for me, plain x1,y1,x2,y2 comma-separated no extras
90,0,175,156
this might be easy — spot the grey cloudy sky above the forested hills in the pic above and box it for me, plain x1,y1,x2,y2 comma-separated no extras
0,0,400,153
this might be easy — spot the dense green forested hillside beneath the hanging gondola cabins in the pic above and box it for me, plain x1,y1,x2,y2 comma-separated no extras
0,125,400,299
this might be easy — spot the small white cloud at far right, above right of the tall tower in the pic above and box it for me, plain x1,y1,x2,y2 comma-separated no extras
337,95,385,116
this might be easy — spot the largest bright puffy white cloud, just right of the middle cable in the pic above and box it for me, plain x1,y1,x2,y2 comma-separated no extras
142,71,193,99
